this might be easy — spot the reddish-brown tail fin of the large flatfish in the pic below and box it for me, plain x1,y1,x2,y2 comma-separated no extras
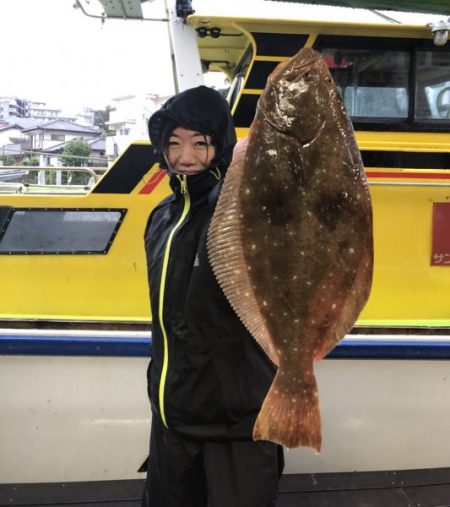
253,370,322,452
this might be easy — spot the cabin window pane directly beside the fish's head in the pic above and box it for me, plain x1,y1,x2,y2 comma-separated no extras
322,48,410,119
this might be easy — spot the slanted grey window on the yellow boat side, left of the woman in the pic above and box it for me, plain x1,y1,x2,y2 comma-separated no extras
0,208,126,254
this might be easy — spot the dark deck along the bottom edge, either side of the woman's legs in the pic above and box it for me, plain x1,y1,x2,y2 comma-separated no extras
0,468,450,507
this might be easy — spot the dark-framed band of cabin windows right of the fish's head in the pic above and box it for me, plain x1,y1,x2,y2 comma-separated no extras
314,35,450,132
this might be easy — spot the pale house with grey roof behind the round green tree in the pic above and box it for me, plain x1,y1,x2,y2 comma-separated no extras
23,119,104,166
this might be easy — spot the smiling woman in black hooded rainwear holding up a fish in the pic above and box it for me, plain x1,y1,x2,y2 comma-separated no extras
142,86,283,507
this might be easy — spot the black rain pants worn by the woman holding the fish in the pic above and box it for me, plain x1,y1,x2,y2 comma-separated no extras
142,416,284,507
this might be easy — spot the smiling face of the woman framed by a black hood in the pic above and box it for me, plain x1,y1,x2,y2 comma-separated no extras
165,127,216,176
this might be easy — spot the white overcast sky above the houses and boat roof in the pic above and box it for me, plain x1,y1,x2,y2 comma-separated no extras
0,0,437,114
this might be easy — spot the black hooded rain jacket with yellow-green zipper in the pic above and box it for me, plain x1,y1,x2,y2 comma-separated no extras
145,87,275,441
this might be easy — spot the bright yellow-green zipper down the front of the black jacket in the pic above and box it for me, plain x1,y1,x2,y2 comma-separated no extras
158,175,191,428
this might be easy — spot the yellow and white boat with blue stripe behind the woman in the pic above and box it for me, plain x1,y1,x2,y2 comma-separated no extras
0,1,450,496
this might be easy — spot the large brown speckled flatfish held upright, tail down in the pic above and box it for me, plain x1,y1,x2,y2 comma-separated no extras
208,48,373,452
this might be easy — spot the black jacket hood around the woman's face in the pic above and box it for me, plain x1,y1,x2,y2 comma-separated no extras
148,85,236,169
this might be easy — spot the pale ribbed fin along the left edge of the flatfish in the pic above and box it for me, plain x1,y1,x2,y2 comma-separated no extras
208,139,279,365
